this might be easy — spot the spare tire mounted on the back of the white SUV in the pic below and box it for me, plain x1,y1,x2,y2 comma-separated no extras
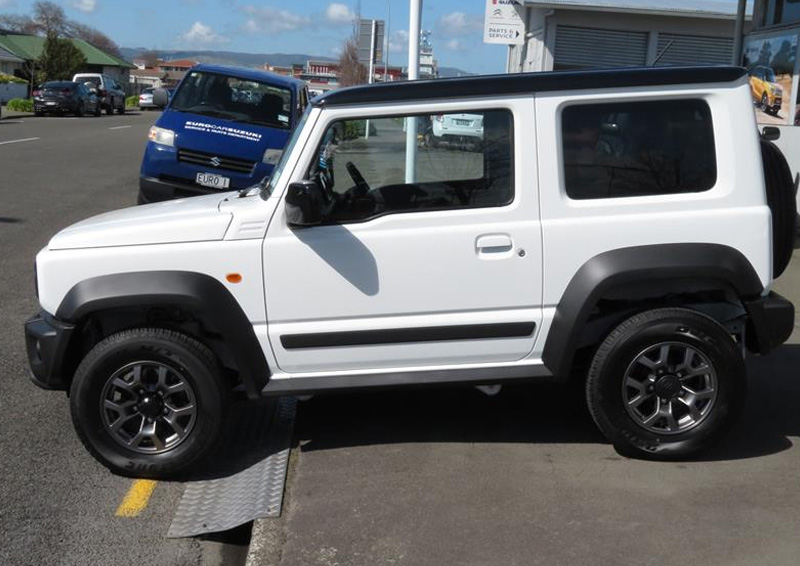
761,139,797,279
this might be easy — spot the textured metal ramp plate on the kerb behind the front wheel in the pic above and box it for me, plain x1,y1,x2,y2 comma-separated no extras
167,398,297,538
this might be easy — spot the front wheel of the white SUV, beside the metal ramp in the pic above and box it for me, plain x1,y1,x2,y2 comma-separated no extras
70,328,230,478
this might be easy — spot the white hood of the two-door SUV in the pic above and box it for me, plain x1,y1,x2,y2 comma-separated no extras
48,193,233,250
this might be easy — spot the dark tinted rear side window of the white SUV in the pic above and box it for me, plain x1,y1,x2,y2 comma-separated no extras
561,100,717,200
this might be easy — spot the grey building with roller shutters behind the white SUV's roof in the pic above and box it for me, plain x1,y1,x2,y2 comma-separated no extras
508,0,752,72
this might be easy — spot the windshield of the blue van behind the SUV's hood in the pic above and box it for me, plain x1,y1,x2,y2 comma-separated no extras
170,71,292,130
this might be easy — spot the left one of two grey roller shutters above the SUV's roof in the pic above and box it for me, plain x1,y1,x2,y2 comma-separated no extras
554,26,648,68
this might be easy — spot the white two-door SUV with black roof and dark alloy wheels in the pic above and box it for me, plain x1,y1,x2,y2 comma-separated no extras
26,68,794,477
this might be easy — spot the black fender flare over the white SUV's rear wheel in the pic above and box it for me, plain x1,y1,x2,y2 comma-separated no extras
542,243,764,379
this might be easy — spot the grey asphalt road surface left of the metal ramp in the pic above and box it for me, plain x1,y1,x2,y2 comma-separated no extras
0,108,214,566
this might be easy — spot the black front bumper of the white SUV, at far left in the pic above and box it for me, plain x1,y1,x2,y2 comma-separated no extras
25,312,75,391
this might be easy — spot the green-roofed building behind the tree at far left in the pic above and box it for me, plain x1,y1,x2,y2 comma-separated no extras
0,32,135,85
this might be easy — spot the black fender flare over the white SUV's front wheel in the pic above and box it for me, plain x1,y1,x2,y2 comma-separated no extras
56,271,270,398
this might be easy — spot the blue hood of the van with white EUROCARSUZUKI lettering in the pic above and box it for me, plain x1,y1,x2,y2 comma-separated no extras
156,109,291,163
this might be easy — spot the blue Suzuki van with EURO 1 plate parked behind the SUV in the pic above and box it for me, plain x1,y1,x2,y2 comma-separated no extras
138,65,308,204
